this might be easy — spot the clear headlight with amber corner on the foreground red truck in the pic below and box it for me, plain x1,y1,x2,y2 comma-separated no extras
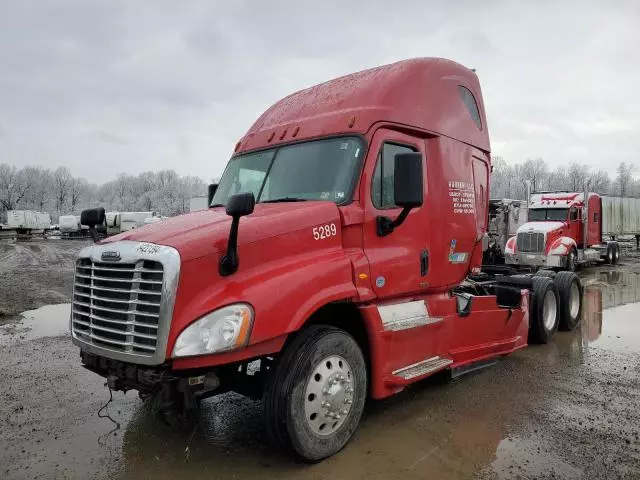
173,303,253,357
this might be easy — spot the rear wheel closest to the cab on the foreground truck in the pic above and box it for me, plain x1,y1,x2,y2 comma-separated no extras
529,277,559,343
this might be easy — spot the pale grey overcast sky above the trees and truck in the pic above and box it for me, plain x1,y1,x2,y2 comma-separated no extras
0,0,640,183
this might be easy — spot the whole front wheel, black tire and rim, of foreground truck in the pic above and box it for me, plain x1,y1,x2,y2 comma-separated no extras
263,325,367,463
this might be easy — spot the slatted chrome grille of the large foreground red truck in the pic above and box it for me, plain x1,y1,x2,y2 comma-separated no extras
71,258,164,356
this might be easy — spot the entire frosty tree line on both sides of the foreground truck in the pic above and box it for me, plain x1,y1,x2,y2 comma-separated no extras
0,157,640,223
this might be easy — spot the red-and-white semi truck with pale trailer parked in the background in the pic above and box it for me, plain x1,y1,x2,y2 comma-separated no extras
505,192,640,271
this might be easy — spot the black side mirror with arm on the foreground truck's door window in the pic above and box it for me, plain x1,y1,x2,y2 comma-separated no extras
376,152,424,237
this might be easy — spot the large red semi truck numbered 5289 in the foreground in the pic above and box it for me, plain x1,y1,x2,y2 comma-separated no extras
70,58,581,462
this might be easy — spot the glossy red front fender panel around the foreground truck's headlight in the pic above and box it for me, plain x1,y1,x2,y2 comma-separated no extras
166,230,358,366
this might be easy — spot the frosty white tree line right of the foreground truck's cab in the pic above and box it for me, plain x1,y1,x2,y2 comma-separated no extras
490,157,640,199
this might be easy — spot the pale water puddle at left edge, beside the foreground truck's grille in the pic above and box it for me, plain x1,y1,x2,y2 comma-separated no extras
0,303,71,344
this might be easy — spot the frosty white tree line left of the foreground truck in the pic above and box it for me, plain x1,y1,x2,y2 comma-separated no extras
0,163,207,223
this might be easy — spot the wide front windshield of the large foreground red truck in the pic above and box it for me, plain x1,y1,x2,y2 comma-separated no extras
211,137,364,206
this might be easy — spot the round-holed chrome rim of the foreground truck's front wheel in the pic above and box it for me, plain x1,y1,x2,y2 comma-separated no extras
304,355,354,436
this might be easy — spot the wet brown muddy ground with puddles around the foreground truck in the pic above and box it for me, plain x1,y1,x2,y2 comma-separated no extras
0,240,640,480
